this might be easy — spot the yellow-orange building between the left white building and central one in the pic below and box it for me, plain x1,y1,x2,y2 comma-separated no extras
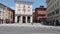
5,7,15,23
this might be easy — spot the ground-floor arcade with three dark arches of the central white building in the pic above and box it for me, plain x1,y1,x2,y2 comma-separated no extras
15,16,32,23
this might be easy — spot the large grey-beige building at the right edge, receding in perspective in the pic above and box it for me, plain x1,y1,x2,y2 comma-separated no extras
46,0,60,25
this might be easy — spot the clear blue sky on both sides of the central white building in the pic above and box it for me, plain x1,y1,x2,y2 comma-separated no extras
0,0,46,10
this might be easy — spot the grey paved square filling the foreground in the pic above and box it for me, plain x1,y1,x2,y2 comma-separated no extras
0,26,60,34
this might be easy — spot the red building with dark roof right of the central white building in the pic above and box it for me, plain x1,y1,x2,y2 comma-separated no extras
33,6,47,23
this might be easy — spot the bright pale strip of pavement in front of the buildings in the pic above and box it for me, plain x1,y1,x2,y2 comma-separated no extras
0,23,60,28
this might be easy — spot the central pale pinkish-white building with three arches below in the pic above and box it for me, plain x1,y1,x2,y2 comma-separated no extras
15,0,33,23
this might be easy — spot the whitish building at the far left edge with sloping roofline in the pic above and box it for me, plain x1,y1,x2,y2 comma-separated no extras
0,3,8,23
